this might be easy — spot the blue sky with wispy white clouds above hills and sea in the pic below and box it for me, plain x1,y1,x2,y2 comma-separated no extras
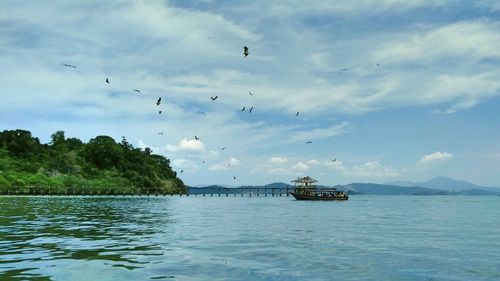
0,0,500,187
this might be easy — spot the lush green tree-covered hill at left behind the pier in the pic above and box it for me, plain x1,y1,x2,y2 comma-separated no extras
0,130,185,193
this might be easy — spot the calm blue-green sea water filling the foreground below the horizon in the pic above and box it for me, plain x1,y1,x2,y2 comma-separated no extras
0,196,500,281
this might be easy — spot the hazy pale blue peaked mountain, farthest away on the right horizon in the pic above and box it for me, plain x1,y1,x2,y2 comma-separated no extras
387,176,500,192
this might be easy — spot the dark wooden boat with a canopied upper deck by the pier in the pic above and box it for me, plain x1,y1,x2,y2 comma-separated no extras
290,176,349,201
